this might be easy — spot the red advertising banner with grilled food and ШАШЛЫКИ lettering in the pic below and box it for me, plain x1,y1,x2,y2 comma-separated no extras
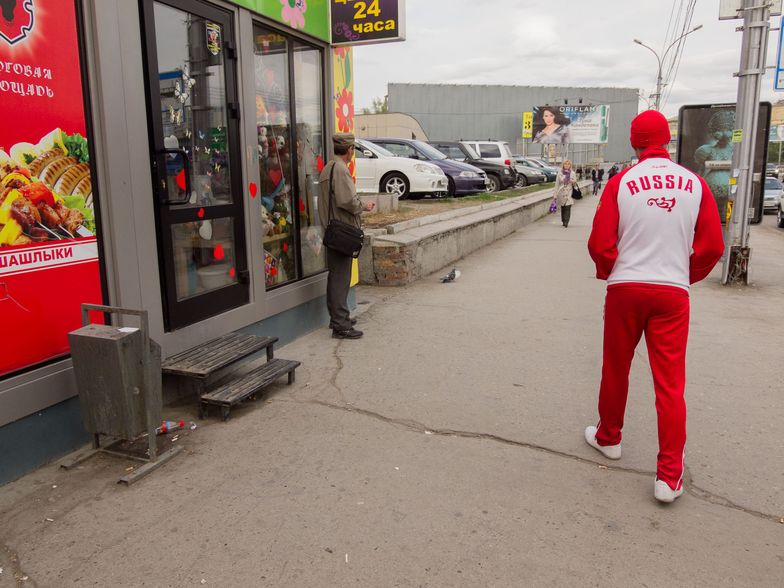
0,0,101,377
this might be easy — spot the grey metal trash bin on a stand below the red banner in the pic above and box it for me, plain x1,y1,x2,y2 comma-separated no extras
61,304,182,484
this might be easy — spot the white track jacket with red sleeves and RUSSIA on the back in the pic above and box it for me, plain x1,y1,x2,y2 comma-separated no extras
588,147,724,290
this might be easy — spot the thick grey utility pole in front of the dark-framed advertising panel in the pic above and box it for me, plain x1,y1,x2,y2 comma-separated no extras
721,0,771,284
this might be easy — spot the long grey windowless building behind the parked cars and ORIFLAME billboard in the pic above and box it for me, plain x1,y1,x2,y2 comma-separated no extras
387,84,639,164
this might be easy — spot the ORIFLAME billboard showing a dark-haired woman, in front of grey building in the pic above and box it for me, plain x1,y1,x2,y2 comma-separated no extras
533,104,610,145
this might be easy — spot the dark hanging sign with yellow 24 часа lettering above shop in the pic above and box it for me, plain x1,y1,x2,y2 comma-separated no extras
331,0,406,45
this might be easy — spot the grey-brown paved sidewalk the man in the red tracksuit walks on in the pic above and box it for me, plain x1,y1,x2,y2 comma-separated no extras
0,197,784,587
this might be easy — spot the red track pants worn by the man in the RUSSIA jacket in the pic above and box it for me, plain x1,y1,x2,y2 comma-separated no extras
596,284,689,490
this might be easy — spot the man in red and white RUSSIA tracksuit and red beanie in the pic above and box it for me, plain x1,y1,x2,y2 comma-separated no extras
585,110,724,502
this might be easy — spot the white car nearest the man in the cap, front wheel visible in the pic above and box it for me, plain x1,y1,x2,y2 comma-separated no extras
354,139,448,199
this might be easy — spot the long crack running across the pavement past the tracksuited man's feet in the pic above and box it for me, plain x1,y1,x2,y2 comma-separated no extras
275,398,784,524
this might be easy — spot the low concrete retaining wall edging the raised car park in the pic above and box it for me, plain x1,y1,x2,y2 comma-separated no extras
359,183,584,286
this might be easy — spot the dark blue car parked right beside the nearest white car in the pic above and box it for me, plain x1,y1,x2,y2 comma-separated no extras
368,138,487,196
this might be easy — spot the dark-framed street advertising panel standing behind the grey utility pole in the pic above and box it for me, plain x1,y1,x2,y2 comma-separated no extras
678,102,771,224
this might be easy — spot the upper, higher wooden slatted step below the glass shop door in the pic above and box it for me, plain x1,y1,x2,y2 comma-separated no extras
161,333,278,379
